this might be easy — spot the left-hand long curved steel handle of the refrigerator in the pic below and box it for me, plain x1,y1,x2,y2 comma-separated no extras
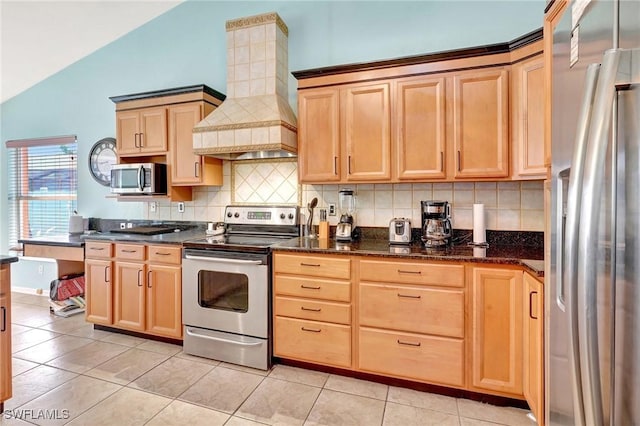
556,64,600,425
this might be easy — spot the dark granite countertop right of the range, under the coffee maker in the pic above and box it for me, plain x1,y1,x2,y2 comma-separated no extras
273,237,544,277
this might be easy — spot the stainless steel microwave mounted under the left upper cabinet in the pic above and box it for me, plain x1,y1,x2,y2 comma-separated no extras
111,163,167,195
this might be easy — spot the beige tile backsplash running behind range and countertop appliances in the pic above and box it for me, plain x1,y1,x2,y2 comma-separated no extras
146,159,544,232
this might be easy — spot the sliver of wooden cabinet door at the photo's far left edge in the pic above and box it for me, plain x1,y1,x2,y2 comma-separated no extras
0,265,12,402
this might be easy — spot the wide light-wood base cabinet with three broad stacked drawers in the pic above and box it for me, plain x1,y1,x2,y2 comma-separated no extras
358,258,465,388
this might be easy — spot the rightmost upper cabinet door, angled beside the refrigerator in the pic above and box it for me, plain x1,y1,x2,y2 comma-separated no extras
511,56,547,179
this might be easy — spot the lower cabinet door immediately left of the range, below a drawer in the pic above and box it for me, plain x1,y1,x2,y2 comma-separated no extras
147,264,182,338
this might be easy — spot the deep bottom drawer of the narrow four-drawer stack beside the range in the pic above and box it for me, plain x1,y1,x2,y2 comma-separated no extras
274,317,351,367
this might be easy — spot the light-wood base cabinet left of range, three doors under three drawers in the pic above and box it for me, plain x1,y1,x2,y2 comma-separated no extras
85,241,182,339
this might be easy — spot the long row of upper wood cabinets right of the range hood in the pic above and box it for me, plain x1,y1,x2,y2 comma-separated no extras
294,31,544,183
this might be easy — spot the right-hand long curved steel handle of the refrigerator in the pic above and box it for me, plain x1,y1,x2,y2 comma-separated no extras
577,49,621,426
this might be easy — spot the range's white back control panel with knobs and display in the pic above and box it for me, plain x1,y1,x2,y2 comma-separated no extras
224,206,299,225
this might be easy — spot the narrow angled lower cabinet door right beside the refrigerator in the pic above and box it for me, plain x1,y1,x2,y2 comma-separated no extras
523,272,544,425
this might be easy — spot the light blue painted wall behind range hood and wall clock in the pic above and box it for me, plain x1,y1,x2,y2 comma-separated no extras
0,0,545,252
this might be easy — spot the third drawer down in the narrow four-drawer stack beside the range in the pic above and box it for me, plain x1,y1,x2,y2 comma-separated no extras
274,297,351,325
